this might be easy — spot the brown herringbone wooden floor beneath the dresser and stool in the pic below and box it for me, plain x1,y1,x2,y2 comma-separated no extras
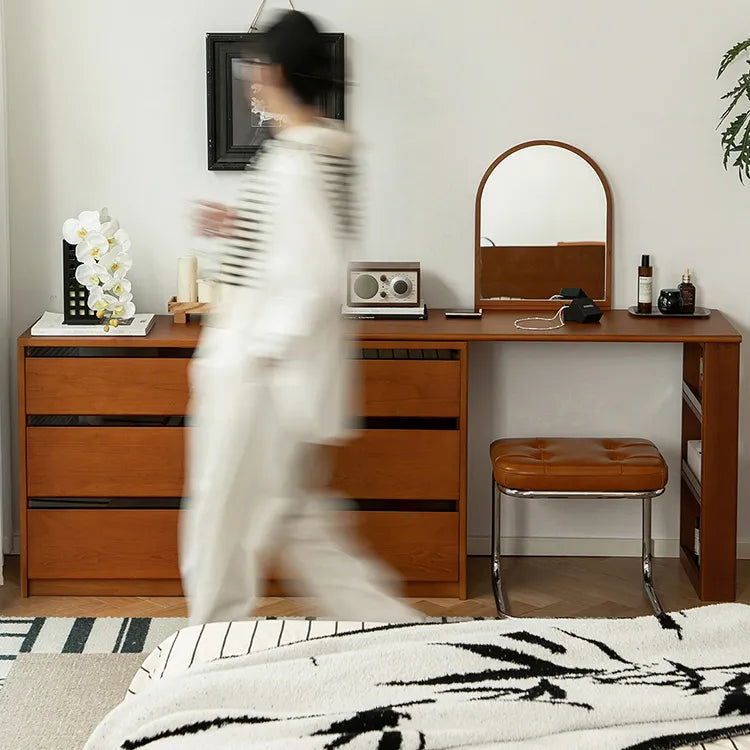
0,557,750,617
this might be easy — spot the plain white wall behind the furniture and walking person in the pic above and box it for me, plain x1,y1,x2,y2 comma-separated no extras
7,0,750,552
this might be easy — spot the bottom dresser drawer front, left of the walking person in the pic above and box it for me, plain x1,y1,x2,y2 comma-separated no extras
27,510,180,580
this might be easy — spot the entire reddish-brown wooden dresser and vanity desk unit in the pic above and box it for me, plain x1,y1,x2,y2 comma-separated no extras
18,310,741,601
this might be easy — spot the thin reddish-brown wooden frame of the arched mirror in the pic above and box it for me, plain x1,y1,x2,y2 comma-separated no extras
474,141,614,310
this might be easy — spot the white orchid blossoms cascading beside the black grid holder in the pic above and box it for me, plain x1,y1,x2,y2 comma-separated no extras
62,208,135,331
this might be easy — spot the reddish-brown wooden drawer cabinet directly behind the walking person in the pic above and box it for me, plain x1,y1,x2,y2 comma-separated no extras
18,316,467,597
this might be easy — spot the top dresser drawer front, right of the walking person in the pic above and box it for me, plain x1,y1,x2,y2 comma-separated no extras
359,359,461,417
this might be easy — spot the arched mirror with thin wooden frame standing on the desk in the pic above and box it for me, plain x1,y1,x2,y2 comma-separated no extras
474,141,612,310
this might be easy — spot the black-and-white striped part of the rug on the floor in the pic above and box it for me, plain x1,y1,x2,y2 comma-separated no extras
0,617,187,686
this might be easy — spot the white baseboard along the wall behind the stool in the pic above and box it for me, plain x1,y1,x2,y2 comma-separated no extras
466,536,750,560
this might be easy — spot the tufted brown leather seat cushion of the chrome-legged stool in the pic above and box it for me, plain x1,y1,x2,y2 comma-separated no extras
490,438,667,493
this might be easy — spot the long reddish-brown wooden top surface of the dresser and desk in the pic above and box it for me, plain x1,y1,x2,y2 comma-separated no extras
18,309,742,348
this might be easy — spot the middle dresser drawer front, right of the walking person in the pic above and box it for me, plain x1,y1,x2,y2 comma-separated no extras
332,430,460,500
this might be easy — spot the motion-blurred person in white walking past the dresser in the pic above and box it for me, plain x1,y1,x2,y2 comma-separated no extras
180,11,420,624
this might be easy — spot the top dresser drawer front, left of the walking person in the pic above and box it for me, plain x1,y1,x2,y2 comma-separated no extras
26,357,190,416
